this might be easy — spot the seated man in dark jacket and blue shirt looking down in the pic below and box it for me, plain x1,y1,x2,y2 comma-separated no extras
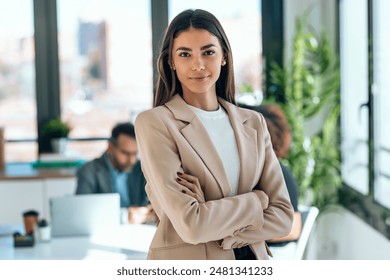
76,123,154,224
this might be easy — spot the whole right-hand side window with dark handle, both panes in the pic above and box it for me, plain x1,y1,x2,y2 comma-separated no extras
340,0,390,239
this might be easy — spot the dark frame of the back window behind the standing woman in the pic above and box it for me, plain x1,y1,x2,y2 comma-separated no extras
5,0,283,158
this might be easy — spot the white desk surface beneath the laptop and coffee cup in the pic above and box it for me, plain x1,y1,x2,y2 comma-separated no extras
0,225,156,260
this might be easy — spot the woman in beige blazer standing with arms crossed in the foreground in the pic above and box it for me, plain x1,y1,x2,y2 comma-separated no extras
135,10,293,259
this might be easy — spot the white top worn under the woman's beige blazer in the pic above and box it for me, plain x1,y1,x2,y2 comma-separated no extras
188,105,240,196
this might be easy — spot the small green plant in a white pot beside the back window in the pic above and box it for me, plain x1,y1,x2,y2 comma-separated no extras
41,118,71,154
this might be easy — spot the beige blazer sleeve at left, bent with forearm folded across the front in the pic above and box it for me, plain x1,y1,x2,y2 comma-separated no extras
135,109,263,244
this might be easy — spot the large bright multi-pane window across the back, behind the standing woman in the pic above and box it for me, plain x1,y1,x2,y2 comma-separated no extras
0,0,272,162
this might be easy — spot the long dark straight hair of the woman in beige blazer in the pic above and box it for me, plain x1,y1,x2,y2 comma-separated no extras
154,9,235,107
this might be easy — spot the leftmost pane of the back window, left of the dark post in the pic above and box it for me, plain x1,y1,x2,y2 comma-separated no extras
0,0,38,162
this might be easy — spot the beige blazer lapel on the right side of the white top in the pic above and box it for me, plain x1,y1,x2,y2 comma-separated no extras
218,98,259,194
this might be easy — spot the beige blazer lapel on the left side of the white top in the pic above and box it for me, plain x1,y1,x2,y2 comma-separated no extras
165,94,231,197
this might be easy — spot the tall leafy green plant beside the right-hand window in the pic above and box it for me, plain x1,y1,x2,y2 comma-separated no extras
268,13,341,209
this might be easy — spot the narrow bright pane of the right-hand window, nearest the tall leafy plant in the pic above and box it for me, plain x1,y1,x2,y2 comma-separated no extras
340,0,369,194
